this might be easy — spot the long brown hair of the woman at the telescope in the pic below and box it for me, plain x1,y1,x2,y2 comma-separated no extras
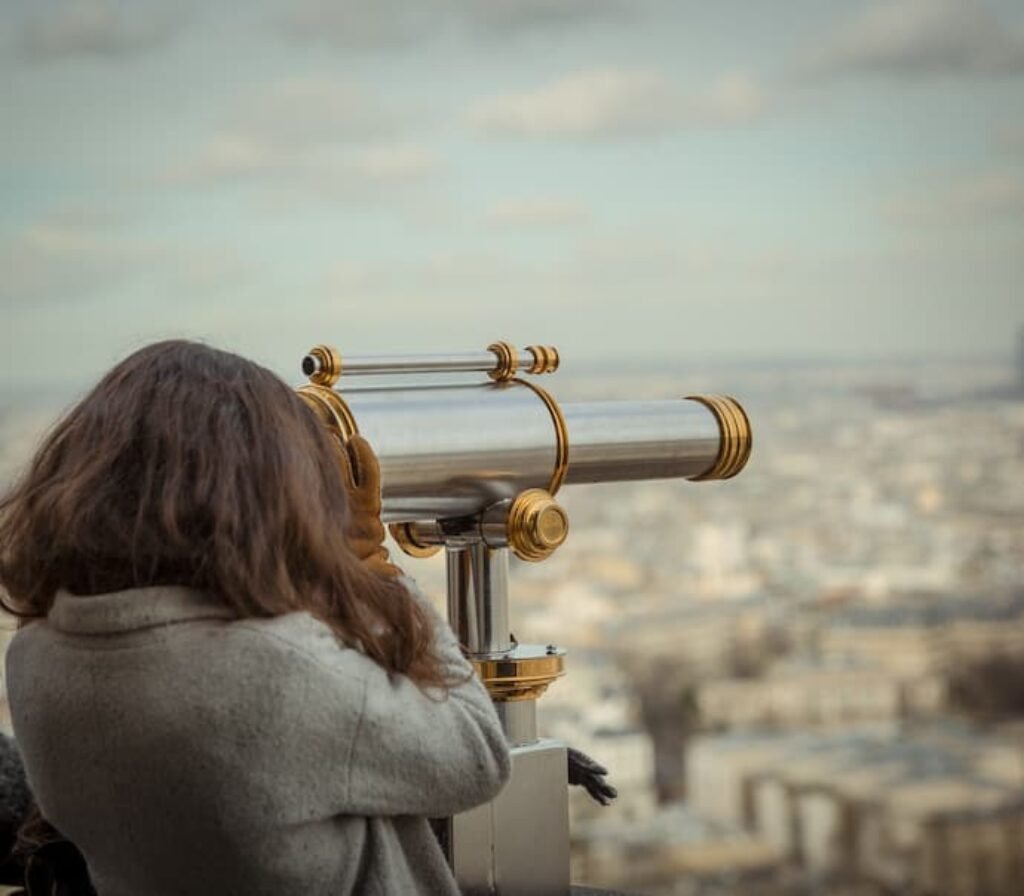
0,340,446,685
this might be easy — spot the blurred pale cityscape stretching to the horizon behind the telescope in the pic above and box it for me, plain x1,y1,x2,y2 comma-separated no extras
0,339,1024,896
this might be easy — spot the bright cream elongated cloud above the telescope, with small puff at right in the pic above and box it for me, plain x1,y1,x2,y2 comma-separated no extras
467,68,768,138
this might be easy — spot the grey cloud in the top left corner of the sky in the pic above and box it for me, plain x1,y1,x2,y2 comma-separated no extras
19,0,184,60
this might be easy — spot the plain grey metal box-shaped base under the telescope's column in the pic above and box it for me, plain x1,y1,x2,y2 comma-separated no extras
445,738,569,896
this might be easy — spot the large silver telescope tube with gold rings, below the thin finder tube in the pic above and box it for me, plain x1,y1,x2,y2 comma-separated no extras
300,380,751,522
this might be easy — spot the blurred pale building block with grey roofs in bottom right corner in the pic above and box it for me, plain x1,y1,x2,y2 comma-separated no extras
688,725,1024,896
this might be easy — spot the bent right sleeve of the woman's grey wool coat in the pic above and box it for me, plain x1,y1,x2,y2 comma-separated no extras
349,582,510,816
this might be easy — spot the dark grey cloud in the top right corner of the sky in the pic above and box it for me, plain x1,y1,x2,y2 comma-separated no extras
799,0,1024,77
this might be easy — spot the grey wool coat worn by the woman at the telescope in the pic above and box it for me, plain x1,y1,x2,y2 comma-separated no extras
7,588,509,896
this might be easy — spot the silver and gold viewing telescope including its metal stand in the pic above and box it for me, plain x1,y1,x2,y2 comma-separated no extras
298,342,752,896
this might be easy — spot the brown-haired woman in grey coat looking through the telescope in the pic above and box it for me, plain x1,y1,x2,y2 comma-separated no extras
0,341,509,896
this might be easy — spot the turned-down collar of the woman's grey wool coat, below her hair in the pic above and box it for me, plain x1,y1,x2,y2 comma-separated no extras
47,586,238,635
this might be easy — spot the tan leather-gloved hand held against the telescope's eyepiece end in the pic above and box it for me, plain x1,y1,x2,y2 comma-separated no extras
339,434,402,579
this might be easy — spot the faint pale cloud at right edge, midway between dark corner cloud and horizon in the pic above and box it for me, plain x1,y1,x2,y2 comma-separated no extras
883,170,1024,226
